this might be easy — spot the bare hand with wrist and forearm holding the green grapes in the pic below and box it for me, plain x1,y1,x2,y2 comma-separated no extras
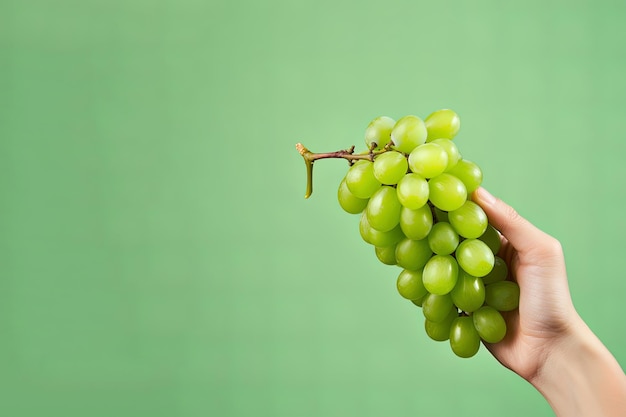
472,188,626,417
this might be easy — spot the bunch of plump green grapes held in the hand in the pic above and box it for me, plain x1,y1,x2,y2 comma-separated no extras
338,109,519,358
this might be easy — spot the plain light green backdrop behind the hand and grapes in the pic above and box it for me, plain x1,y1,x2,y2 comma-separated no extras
0,0,626,417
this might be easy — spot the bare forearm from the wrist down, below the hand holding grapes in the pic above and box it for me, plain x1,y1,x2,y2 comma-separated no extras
529,321,626,417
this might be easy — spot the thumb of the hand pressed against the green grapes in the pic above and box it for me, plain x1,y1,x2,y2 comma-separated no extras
472,187,548,252
